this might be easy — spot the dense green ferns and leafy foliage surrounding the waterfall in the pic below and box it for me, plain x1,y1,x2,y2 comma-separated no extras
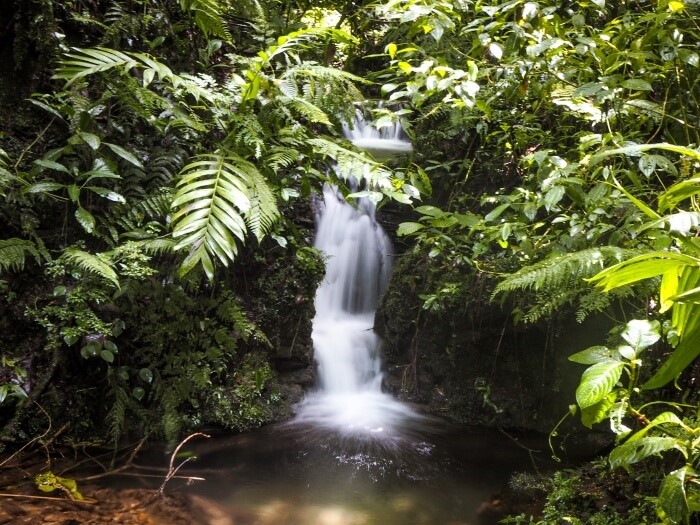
0,0,700,523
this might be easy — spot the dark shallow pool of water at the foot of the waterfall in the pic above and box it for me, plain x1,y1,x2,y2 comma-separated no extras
142,421,548,525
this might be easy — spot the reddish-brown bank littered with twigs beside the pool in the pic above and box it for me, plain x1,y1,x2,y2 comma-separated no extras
0,447,241,525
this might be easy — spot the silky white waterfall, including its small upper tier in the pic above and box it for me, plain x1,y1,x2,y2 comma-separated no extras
296,109,419,435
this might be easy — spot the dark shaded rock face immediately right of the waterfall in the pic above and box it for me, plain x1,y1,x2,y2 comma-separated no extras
375,249,609,432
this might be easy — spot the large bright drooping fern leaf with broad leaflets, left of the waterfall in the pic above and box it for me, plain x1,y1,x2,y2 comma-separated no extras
172,154,261,279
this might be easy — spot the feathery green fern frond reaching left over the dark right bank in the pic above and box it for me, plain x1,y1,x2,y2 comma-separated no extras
492,246,637,299
